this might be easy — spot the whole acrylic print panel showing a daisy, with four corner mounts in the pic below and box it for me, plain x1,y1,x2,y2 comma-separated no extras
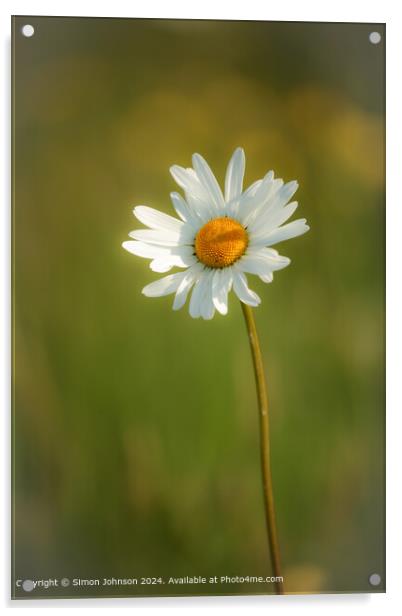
12,16,385,599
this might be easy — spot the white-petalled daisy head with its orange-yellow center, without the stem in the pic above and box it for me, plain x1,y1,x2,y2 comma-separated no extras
123,148,309,319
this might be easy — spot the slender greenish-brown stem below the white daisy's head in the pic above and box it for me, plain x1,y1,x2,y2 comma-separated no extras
240,302,284,595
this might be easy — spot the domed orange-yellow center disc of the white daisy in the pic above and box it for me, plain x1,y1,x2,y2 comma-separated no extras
195,216,248,268
